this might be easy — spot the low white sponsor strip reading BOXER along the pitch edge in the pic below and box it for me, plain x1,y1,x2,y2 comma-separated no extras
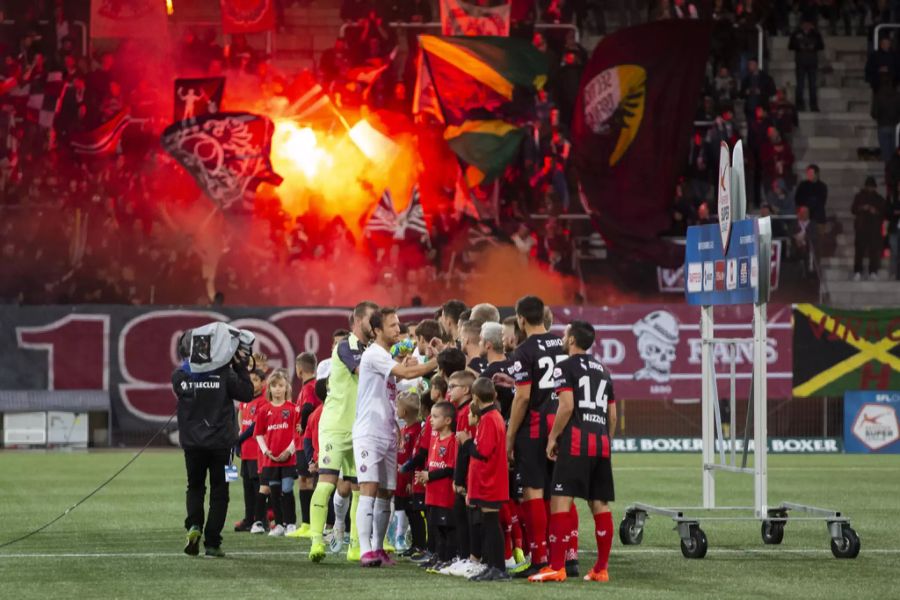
612,437,843,454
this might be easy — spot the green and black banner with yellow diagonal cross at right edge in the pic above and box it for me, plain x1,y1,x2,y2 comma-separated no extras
794,304,900,397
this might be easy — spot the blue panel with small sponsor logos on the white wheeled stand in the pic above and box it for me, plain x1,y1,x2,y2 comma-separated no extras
684,219,759,306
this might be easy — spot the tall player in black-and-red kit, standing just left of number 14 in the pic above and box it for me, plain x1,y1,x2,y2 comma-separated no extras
506,296,565,577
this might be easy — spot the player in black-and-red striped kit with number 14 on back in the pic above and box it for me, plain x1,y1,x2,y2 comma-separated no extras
529,321,616,582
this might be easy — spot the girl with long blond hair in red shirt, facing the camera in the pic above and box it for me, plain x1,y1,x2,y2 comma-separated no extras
254,369,297,537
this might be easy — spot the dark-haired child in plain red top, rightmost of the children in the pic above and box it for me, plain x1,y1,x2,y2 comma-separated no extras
457,377,510,581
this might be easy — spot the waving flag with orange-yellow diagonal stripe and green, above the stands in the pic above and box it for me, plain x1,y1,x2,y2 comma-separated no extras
414,35,548,185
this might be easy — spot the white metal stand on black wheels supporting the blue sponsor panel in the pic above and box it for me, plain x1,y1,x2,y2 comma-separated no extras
619,142,860,558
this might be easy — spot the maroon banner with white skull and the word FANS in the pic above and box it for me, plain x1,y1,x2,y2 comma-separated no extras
553,304,793,399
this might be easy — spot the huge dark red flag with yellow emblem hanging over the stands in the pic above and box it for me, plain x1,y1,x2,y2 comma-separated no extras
572,20,711,266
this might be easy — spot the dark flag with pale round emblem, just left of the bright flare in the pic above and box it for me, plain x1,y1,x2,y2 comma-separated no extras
161,113,282,209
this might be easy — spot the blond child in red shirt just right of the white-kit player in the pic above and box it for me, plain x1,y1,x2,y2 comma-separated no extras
394,391,425,556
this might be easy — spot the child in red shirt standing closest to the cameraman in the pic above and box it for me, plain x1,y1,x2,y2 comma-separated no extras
234,369,266,533
